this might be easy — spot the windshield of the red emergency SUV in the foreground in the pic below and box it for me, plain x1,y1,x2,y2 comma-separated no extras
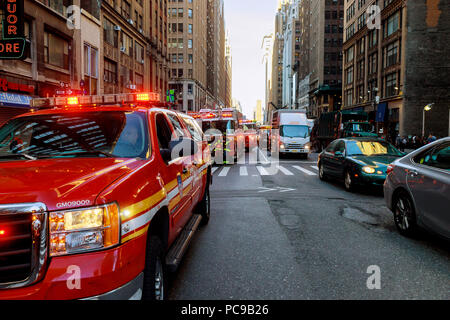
0,112,149,161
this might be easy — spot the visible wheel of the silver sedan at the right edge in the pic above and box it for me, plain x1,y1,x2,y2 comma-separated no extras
394,192,418,237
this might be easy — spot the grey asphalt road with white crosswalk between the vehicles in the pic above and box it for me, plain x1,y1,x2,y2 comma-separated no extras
169,150,450,300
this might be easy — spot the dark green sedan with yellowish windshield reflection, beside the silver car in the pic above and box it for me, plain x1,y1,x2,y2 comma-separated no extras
318,138,405,191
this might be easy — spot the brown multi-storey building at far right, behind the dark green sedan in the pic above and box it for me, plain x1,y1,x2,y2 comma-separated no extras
342,0,450,140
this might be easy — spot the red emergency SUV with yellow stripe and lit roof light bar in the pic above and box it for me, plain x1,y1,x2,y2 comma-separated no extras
0,94,211,300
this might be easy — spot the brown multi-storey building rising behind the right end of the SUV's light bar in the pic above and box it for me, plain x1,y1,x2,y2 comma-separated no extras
100,0,168,99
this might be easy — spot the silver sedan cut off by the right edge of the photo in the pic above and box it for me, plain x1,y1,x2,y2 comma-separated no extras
384,137,450,239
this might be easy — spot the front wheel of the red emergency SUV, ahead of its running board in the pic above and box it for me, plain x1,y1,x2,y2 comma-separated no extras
142,236,166,301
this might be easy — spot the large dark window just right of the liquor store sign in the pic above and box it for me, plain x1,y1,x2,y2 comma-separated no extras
44,31,69,70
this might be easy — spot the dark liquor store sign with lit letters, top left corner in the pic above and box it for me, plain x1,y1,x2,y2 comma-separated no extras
0,0,26,60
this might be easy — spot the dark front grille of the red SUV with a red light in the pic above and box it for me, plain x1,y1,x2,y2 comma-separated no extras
0,213,33,284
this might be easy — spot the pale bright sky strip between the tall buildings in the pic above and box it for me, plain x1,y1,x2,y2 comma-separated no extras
224,0,278,119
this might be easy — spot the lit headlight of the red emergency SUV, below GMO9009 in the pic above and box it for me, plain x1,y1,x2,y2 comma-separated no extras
50,204,120,256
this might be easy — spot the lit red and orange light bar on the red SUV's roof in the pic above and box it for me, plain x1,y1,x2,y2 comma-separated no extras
30,93,161,109
